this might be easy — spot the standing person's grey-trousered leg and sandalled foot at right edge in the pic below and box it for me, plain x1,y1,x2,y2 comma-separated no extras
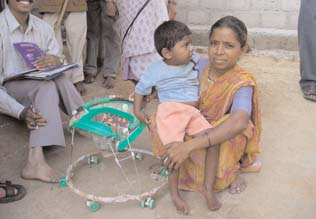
298,0,316,101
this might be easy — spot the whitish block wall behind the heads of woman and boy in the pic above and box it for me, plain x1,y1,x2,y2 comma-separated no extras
177,0,300,50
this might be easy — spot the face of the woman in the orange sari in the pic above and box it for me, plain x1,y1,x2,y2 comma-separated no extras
208,27,244,74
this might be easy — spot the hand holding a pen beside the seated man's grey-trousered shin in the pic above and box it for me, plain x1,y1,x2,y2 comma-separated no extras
20,108,47,130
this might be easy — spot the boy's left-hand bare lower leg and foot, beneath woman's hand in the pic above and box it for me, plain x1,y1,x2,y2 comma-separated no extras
168,170,189,214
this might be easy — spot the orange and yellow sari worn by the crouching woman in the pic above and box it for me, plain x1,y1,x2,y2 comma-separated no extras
151,65,261,191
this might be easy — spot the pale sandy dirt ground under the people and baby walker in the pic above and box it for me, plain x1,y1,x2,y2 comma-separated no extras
0,55,316,219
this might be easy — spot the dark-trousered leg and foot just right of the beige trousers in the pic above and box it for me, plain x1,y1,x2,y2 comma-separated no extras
83,0,101,83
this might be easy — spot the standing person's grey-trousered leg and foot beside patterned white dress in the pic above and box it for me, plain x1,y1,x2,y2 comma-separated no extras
100,1,121,89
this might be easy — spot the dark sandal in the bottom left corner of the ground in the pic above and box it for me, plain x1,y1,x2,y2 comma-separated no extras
0,181,26,203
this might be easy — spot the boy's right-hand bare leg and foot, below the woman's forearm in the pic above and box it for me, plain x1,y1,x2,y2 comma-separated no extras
202,145,221,211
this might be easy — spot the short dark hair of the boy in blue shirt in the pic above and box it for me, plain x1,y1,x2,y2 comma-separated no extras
154,20,192,57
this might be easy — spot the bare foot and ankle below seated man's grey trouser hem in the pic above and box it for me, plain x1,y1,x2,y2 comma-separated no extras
22,147,61,183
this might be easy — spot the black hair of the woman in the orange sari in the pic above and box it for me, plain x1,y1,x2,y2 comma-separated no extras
209,16,248,48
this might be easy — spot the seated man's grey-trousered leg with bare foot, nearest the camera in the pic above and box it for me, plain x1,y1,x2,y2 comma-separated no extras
4,80,65,182
